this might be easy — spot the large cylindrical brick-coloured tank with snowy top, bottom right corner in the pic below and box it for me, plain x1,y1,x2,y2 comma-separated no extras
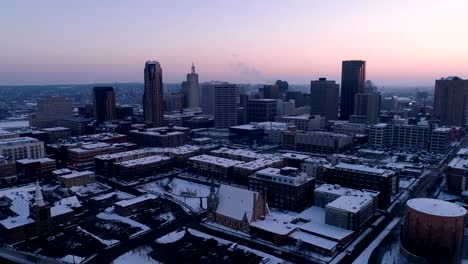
401,198,466,263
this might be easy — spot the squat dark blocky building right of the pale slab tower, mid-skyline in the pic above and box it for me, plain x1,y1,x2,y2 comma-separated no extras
247,99,276,122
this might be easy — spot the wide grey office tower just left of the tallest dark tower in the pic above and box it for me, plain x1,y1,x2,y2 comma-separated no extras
310,78,340,120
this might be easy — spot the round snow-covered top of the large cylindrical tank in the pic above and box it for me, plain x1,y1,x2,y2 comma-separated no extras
406,198,466,217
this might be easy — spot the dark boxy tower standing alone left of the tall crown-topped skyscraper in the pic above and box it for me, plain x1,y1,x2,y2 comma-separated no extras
93,86,115,122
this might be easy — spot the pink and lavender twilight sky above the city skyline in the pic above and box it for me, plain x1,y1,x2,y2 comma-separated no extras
0,0,468,86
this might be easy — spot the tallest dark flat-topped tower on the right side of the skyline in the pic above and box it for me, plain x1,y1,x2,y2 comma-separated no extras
340,60,366,120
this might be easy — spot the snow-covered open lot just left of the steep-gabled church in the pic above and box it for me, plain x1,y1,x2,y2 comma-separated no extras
141,178,210,212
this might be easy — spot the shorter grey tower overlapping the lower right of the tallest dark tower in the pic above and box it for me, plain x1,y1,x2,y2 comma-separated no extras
352,93,380,124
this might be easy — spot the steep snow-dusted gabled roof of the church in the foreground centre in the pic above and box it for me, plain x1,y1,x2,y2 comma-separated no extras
216,184,260,222
